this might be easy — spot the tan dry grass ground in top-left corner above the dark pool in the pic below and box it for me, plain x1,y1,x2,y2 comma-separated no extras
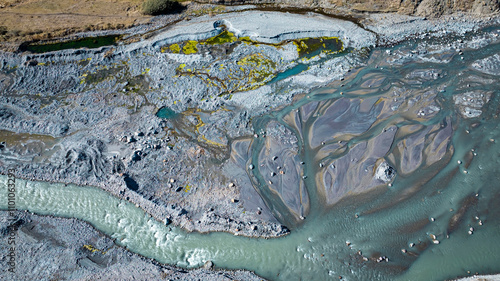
0,0,150,48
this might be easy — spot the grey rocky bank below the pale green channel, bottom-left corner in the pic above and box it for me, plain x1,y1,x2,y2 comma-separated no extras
0,212,261,280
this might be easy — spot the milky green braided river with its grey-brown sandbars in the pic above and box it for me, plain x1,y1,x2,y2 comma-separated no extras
0,28,500,280
